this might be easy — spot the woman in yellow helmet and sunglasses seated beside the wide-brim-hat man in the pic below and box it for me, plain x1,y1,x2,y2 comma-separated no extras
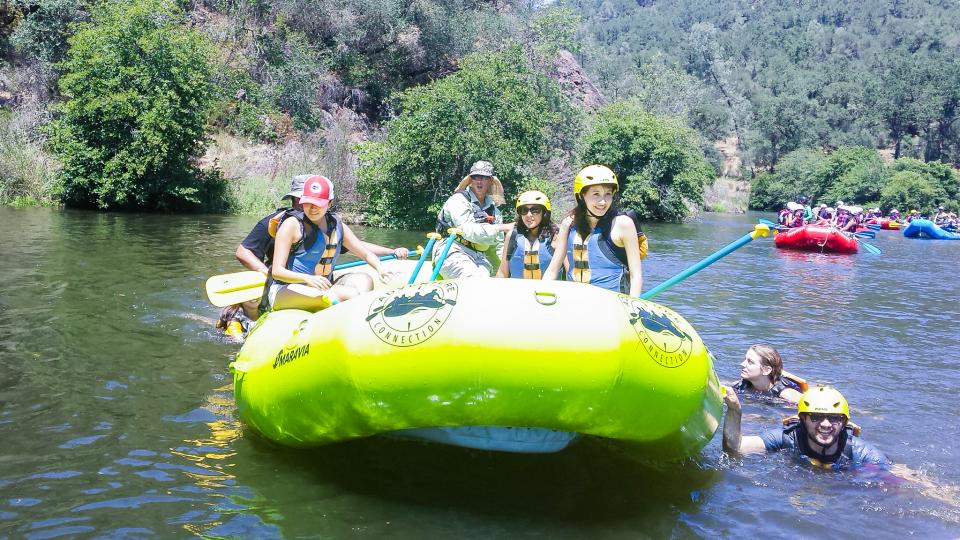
497,191,559,279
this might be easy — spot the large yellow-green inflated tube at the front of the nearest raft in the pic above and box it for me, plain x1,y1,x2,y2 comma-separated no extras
231,278,721,458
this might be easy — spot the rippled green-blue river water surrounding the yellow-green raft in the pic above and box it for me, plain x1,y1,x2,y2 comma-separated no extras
0,208,960,538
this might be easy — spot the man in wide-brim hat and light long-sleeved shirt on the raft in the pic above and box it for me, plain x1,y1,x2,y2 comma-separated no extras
434,160,512,279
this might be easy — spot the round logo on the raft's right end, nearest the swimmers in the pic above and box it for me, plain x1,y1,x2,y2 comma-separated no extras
620,294,693,368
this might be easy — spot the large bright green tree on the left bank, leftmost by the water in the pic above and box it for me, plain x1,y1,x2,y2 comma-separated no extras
50,0,220,209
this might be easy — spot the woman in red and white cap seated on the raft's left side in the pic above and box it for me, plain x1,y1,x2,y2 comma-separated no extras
268,176,390,311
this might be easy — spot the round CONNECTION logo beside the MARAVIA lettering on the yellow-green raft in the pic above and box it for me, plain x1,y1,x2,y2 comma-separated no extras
367,282,458,347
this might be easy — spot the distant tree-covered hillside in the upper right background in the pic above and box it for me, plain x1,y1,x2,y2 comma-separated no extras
566,0,960,169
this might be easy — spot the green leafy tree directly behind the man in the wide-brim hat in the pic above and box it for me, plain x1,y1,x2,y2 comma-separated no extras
358,46,577,227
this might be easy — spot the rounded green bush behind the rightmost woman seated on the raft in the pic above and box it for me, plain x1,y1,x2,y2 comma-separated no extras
579,101,716,221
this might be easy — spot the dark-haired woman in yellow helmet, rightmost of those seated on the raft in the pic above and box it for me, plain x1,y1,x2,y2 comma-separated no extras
543,165,646,297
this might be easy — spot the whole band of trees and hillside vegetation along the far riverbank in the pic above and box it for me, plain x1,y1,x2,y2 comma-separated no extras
0,0,960,219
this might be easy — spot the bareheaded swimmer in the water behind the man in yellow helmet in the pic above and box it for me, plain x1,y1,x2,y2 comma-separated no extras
732,343,807,403
